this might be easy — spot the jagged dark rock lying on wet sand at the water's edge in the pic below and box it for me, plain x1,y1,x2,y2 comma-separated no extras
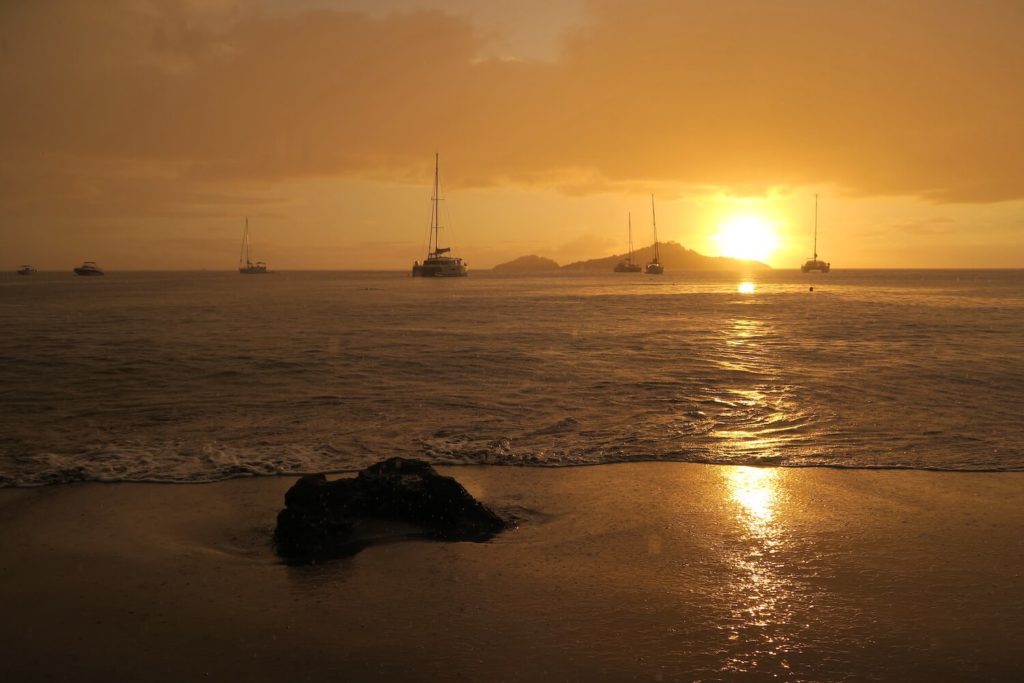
274,458,510,561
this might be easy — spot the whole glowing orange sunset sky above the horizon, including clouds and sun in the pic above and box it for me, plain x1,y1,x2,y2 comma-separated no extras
0,0,1024,269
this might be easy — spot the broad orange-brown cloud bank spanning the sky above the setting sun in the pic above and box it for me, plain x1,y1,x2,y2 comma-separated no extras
0,0,1024,216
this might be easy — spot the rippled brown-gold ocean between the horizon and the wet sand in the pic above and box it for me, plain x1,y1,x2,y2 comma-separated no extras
0,269,1024,486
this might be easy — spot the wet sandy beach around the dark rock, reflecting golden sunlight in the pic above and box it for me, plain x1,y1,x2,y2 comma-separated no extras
0,464,1024,681
